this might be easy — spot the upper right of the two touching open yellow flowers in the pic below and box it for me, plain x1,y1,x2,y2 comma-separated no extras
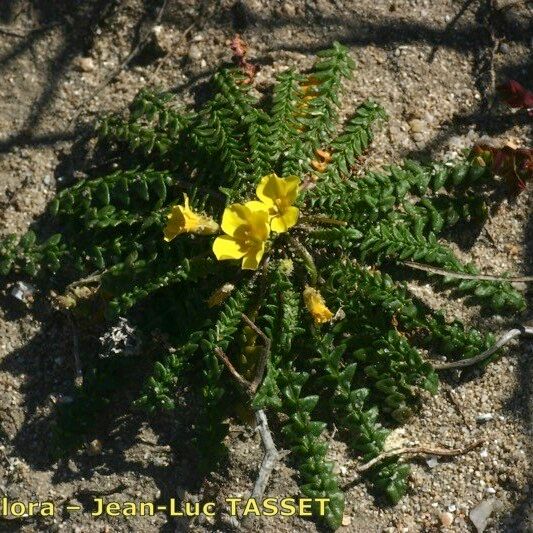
256,174,300,233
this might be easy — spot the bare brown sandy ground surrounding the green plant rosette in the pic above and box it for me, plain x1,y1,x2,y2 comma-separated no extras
0,0,533,532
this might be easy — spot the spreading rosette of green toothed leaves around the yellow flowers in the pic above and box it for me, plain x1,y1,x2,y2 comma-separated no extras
0,44,524,529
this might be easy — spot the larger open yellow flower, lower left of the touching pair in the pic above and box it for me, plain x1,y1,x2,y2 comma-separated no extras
213,201,270,270
